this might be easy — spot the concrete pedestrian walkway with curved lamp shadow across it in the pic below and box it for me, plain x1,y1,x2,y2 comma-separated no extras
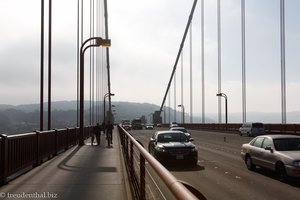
0,128,131,200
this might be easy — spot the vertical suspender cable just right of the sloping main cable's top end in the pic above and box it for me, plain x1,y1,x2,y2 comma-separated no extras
201,0,205,123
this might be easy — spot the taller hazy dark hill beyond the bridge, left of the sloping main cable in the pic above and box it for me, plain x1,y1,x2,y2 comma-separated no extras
0,101,166,134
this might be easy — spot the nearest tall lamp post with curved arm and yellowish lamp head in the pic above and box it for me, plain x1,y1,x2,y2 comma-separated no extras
79,37,111,145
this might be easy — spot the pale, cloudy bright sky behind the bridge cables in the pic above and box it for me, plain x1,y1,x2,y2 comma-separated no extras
0,0,300,122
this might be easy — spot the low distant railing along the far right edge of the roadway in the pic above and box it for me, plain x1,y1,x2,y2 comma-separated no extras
173,123,300,135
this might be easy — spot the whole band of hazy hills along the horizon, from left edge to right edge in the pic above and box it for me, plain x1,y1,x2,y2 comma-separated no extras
0,101,300,134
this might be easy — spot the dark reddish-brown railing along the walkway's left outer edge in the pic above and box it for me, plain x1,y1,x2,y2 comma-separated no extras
0,127,91,185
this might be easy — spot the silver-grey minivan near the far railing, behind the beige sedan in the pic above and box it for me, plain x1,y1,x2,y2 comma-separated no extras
239,122,265,137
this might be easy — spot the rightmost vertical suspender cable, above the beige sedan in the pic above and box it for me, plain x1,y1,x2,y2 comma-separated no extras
280,0,286,124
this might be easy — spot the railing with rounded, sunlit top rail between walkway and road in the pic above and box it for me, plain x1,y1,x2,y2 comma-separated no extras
118,126,206,200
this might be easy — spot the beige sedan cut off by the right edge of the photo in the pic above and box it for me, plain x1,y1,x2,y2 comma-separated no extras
241,134,300,181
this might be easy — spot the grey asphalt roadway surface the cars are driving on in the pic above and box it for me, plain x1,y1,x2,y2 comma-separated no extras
130,129,300,200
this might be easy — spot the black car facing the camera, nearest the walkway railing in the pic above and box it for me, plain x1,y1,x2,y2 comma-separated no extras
148,130,198,165
